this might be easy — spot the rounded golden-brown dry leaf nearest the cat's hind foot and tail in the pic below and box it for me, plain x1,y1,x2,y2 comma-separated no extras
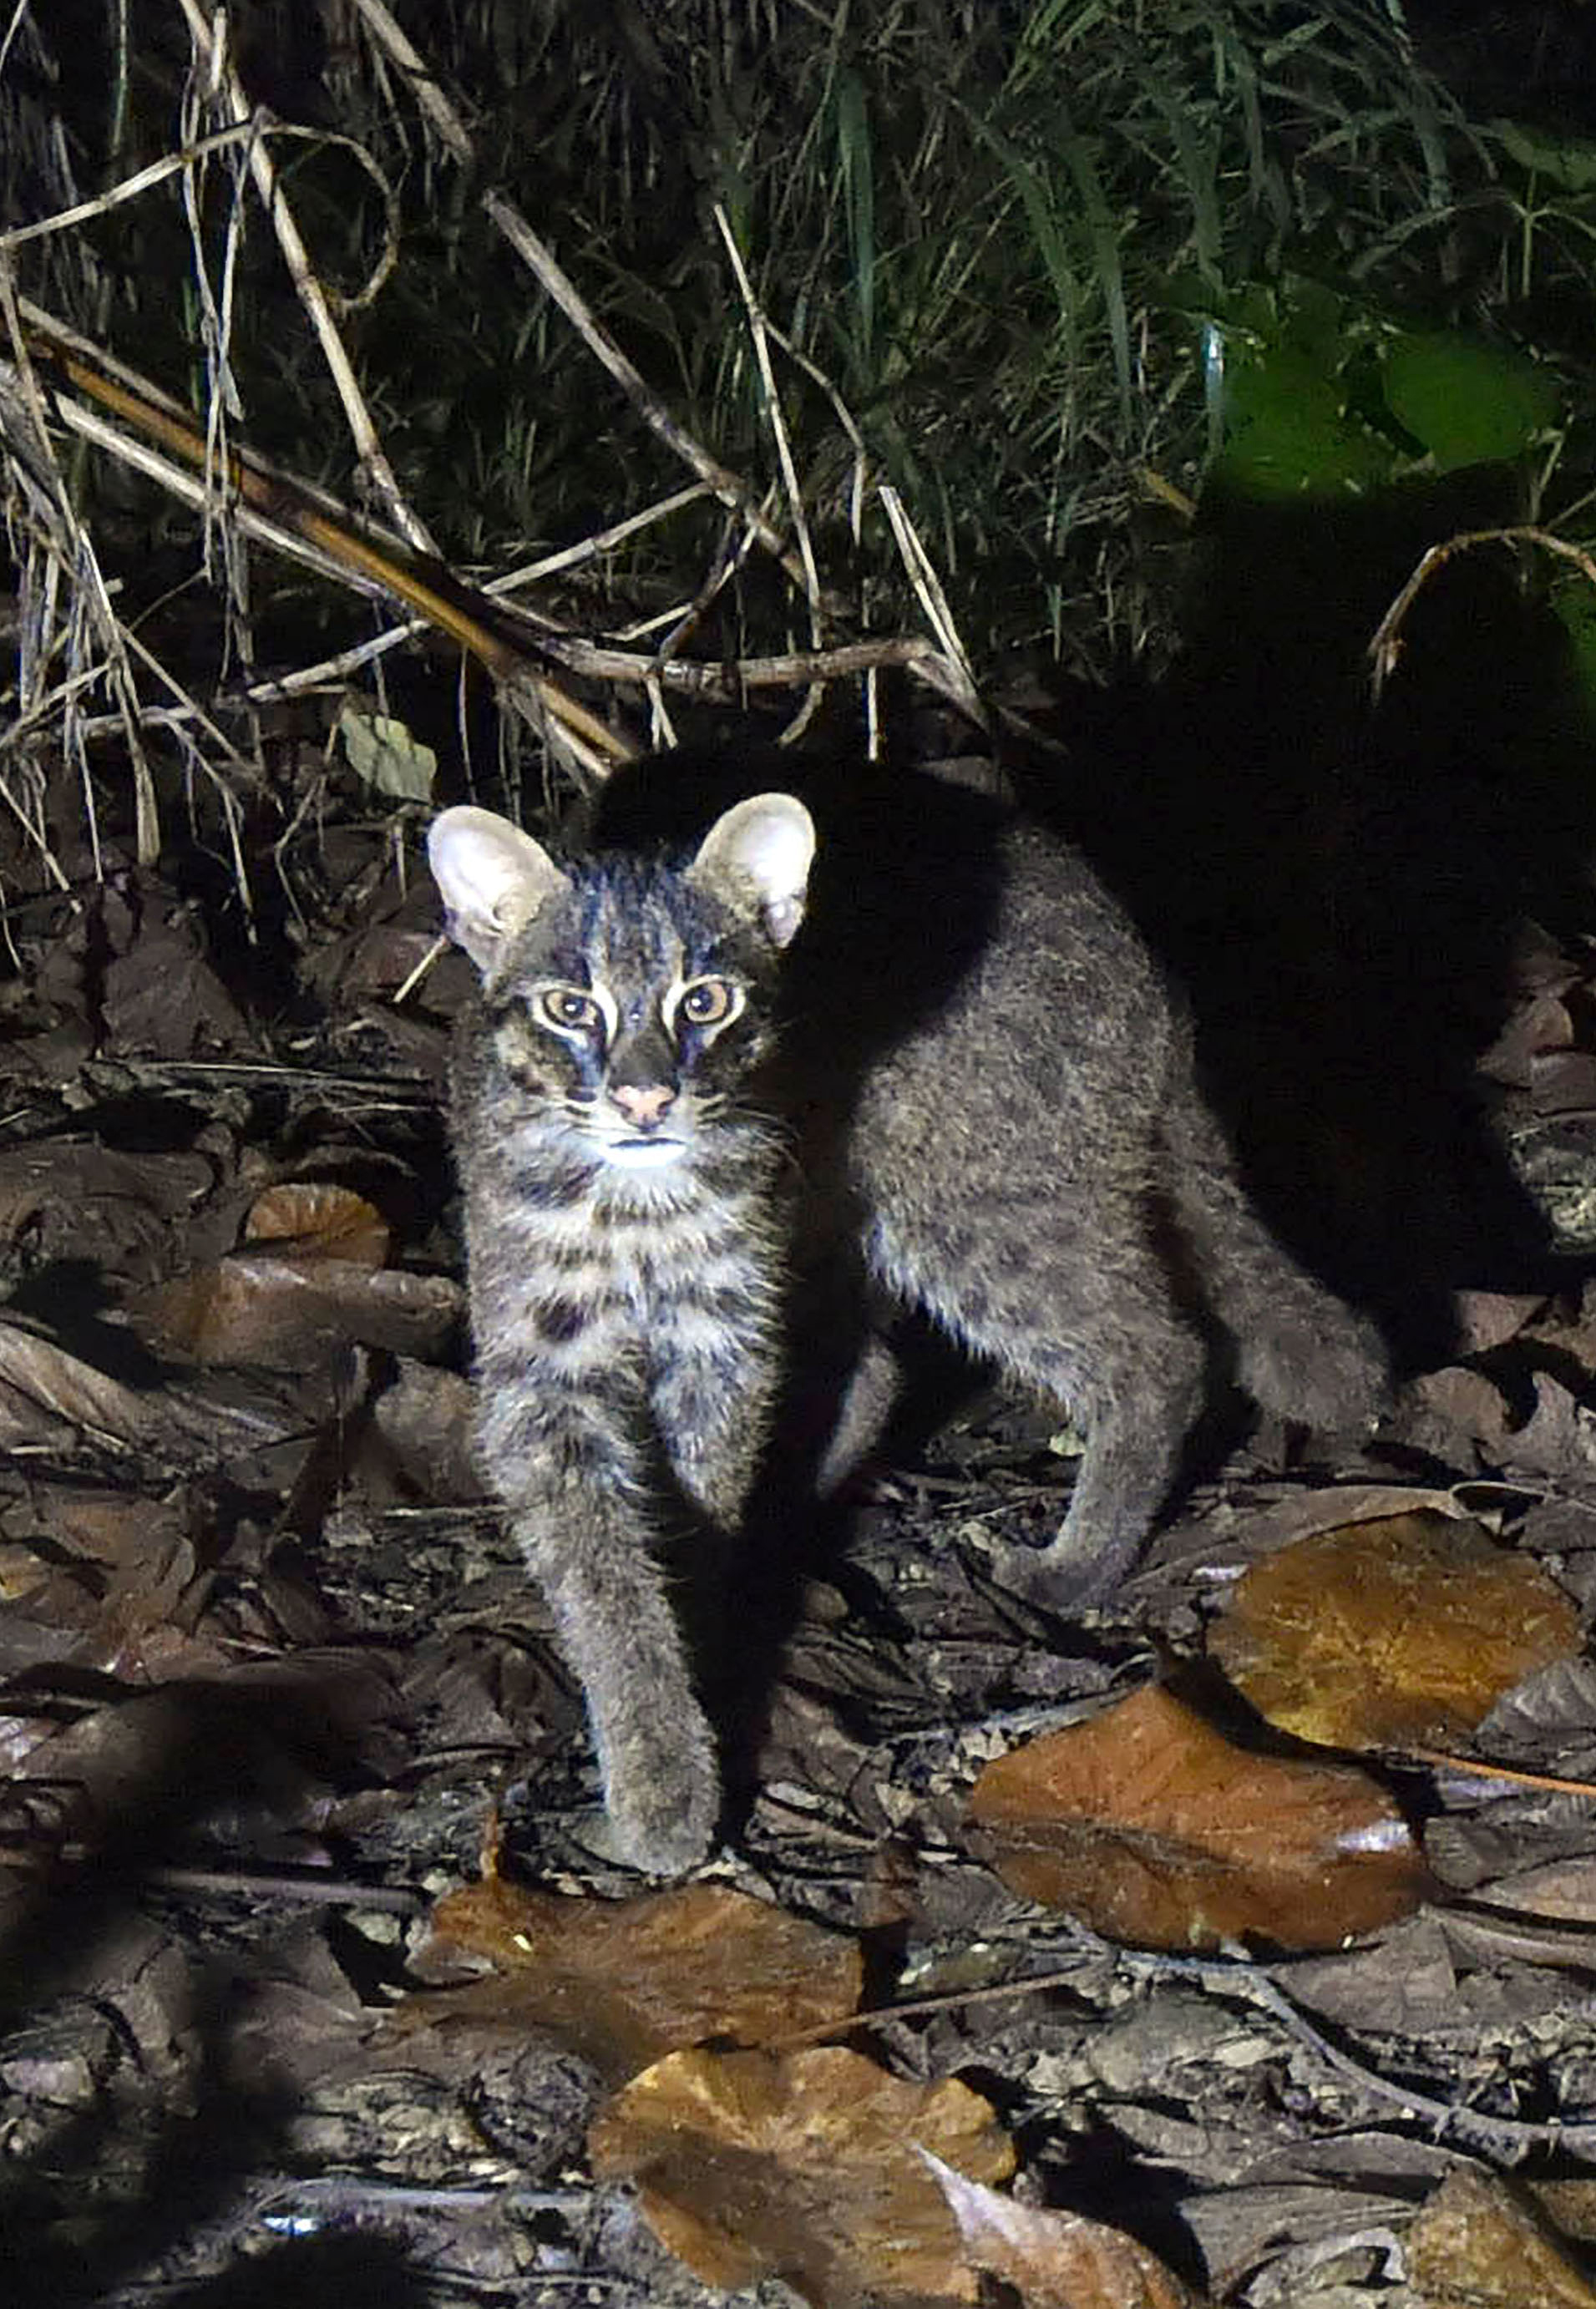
1208,1515,1580,1748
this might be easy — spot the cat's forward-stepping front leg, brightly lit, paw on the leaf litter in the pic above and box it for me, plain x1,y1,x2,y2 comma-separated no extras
478,1371,721,1875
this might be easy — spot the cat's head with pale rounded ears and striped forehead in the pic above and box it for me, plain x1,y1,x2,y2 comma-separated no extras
428,794,815,1171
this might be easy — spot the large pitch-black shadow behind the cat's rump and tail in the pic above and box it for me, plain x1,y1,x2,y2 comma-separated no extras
1010,468,1596,1370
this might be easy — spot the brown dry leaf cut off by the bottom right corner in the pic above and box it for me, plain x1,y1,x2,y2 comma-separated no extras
1406,2166,1596,2309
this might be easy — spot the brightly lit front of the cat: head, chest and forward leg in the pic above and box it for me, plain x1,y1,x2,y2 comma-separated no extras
432,803,813,1872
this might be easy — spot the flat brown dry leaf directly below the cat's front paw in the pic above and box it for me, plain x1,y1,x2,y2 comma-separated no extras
423,1875,862,2080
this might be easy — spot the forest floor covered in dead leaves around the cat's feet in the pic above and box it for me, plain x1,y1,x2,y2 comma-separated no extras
0,780,1596,2309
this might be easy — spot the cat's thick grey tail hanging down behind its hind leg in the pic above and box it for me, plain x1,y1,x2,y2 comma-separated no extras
1164,1087,1391,1434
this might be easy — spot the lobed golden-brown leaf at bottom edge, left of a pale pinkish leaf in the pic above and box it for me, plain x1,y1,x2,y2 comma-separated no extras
589,2048,1014,2309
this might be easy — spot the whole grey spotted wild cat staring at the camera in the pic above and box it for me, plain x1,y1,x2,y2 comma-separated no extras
429,757,1384,1872
